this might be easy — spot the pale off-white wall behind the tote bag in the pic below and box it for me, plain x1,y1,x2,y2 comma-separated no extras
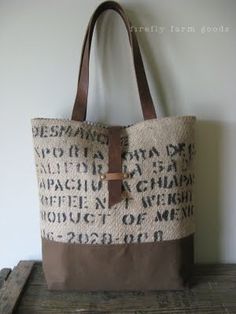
0,0,236,268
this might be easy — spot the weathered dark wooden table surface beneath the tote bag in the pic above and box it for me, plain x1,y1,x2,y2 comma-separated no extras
0,261,236,314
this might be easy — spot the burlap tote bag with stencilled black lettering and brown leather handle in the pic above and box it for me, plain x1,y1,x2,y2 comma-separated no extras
32,1,196,291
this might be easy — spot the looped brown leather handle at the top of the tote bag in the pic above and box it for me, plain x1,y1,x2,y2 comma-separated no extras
72,1,156,121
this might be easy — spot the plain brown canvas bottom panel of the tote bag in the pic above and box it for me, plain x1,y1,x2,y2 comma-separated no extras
42,235,193,291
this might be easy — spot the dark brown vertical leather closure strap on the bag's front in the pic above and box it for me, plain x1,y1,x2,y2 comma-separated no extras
108,126,122,207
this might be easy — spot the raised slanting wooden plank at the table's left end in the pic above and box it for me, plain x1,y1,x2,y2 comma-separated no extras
0,261,34,314
